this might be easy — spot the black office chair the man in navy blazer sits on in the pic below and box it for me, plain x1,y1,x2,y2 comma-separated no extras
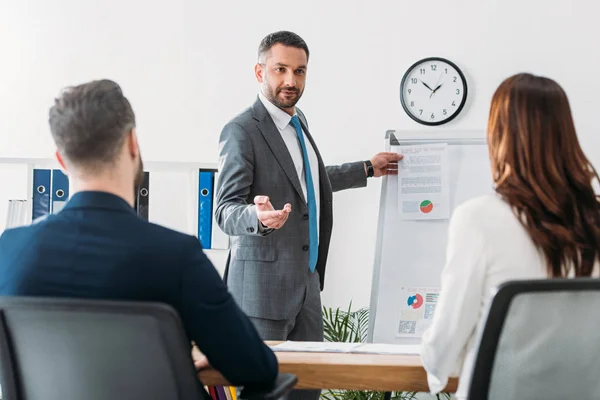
0,297,296,400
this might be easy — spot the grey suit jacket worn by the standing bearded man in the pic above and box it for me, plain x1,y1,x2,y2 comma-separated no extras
215,99,367,320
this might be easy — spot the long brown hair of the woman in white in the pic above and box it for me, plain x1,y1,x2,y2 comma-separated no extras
488,74,600,277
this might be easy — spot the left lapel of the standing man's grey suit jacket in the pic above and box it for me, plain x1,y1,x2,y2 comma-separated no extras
253,99,306,202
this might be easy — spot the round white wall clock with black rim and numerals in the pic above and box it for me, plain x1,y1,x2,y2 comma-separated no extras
400,57,467,125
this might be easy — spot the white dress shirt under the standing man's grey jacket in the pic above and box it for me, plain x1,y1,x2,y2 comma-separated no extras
258,93,321,234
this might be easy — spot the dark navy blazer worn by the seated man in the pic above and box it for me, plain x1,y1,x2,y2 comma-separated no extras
0,192,278,385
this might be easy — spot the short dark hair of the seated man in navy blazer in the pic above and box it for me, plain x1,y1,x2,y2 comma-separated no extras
49,79,135,166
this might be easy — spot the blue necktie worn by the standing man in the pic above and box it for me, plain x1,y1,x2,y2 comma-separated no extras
290,115,319,272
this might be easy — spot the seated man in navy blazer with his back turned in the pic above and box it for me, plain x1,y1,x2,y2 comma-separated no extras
0,80,278,386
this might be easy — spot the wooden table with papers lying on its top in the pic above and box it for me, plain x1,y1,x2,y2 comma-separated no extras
198,342,458,392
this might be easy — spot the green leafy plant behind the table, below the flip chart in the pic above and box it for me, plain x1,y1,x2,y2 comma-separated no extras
321,302,450,400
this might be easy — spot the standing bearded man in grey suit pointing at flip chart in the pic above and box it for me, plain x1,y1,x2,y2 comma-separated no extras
215,31,402,399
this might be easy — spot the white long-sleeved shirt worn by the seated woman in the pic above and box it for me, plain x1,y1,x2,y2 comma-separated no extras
421,194,598,400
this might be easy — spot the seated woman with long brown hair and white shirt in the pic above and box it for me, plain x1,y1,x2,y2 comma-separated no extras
421,74,600,399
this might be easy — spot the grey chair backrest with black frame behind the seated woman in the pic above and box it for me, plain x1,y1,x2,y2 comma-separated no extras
468,278,600,400
